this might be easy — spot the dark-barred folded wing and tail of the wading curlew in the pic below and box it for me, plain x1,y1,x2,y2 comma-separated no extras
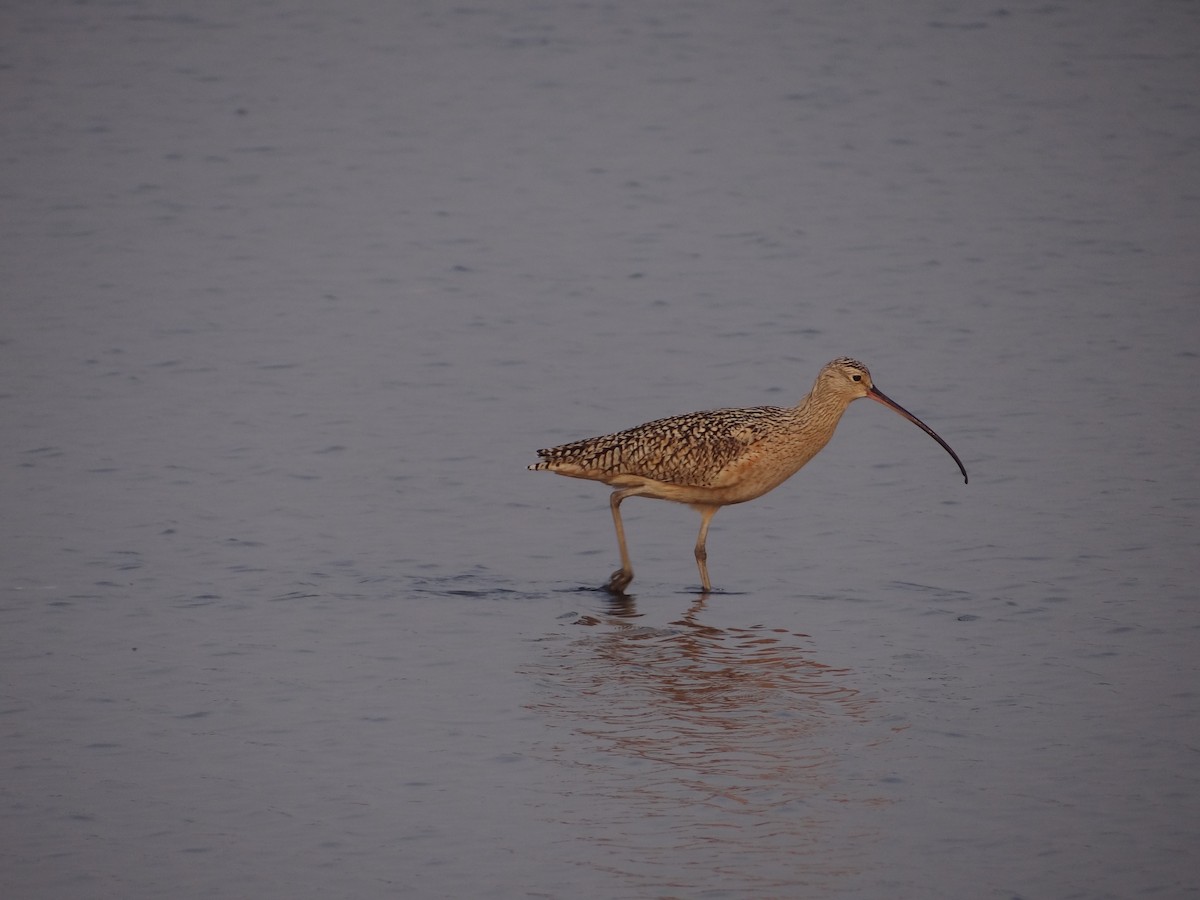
529,407,796,487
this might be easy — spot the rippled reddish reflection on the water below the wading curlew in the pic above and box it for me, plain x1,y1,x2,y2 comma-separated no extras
530,598,894,890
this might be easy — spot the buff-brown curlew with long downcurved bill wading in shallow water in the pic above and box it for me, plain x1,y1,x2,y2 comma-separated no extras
529,356,967,594
